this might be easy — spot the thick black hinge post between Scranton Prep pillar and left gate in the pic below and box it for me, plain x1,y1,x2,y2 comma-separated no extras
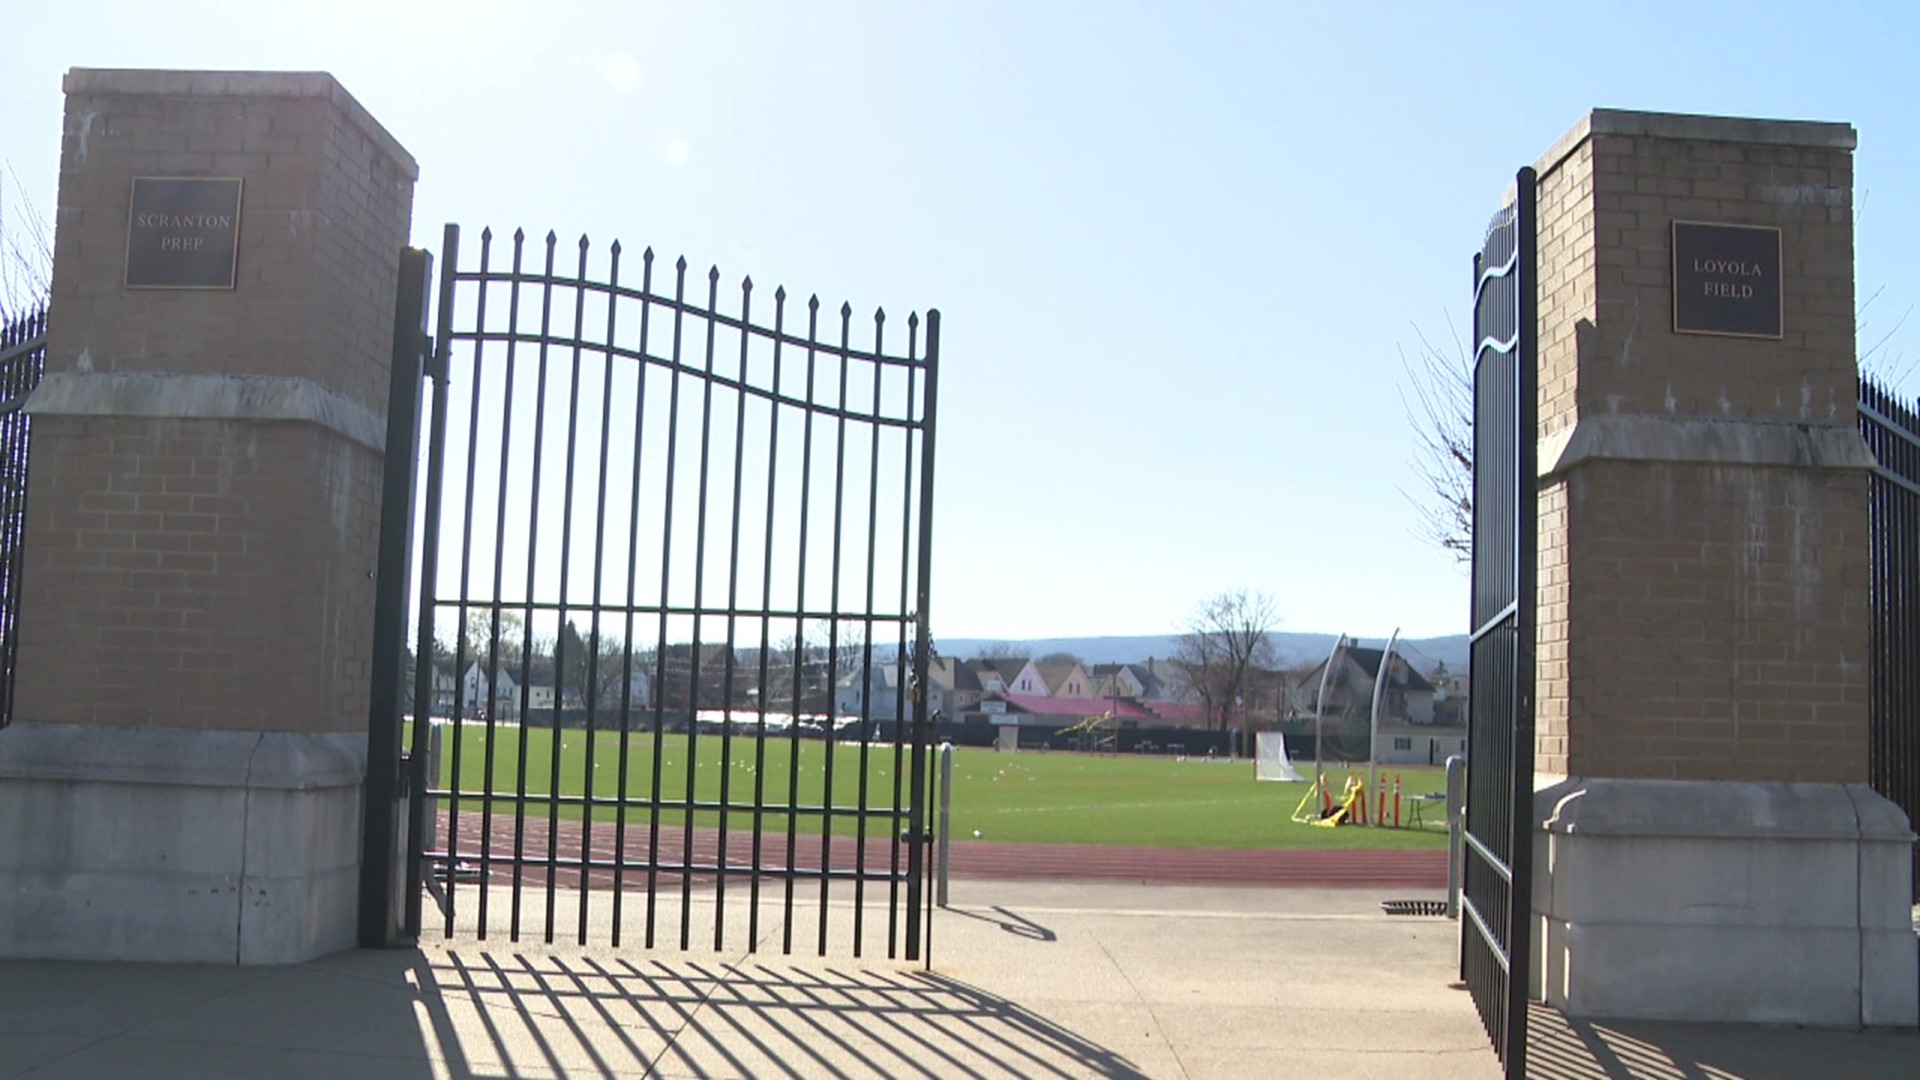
359,242,432,949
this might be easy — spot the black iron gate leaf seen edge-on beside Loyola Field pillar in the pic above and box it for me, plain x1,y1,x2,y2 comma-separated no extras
1459,169,1538,1076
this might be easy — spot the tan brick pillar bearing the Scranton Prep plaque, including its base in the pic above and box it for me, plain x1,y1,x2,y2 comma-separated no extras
0,69,417,963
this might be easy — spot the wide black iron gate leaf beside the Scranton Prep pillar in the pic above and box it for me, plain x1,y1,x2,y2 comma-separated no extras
369,227,939,959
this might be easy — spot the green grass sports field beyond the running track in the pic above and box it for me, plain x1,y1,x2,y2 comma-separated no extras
416,724,1446,849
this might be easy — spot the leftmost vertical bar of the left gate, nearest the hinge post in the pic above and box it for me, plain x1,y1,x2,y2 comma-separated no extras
401,233,461,936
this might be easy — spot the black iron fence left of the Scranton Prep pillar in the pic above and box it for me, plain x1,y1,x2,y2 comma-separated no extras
0,307,46,728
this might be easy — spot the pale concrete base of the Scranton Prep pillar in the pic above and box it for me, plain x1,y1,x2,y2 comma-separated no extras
0,724,367,965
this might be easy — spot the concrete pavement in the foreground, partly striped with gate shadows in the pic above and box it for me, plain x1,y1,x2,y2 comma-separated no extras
0,880,1920,1080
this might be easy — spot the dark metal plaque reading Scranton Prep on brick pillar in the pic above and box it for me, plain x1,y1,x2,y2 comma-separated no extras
127,177,240,288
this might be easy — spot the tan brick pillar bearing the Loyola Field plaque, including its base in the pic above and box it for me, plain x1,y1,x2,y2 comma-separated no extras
1534,110,1916,1024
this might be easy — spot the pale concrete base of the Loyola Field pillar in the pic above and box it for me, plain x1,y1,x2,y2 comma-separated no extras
1530,778,1920,1028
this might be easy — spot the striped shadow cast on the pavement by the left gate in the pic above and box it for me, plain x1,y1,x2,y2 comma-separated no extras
407,942,1144,1078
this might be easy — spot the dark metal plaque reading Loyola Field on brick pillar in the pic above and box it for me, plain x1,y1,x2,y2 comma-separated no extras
1672,221,1782,338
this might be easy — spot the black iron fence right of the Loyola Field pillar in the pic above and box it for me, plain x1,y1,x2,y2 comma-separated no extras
1859,379,1920,901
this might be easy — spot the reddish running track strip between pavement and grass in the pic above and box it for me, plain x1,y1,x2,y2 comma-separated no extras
424,811,1446,890
